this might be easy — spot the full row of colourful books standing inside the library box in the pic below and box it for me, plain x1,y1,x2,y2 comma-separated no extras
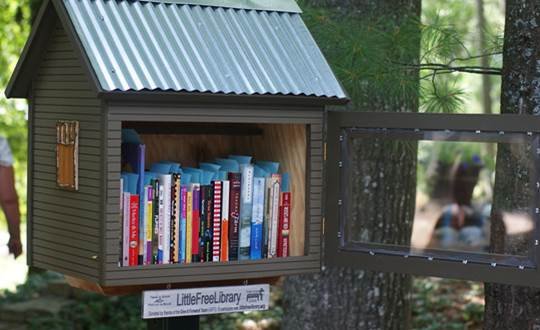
119,130,291,266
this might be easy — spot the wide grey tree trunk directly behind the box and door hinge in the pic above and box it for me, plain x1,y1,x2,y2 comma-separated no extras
283,0,421,330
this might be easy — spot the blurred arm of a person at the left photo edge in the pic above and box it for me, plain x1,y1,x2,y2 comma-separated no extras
0,136,22,258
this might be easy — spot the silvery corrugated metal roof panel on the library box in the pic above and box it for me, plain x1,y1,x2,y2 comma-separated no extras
64,0,346,98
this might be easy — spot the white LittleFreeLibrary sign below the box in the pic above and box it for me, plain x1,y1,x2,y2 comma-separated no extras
142,284,270,319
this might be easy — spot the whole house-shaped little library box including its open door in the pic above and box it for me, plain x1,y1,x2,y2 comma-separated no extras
6,0,540,293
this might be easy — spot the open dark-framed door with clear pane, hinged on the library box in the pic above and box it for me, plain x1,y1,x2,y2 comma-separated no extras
324,112,540,286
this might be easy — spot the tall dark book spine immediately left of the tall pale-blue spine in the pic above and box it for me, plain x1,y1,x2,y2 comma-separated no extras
229,173,242,261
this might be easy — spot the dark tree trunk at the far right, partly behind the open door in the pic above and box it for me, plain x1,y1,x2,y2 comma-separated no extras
484,0,540,330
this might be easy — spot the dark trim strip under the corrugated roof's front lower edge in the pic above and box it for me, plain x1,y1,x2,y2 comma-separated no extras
98,91,350,107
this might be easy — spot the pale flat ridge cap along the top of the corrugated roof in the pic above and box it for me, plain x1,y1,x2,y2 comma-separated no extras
127,0,302,14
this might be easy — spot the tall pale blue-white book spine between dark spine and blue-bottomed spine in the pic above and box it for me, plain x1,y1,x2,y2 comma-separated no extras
238,164,254,260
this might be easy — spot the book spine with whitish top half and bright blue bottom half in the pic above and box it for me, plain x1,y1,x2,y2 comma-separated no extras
250,177,265,260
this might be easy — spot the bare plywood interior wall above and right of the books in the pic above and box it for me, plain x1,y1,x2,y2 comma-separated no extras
140,123,307,256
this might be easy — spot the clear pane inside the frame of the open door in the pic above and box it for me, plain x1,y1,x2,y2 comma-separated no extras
341,129,536,260
